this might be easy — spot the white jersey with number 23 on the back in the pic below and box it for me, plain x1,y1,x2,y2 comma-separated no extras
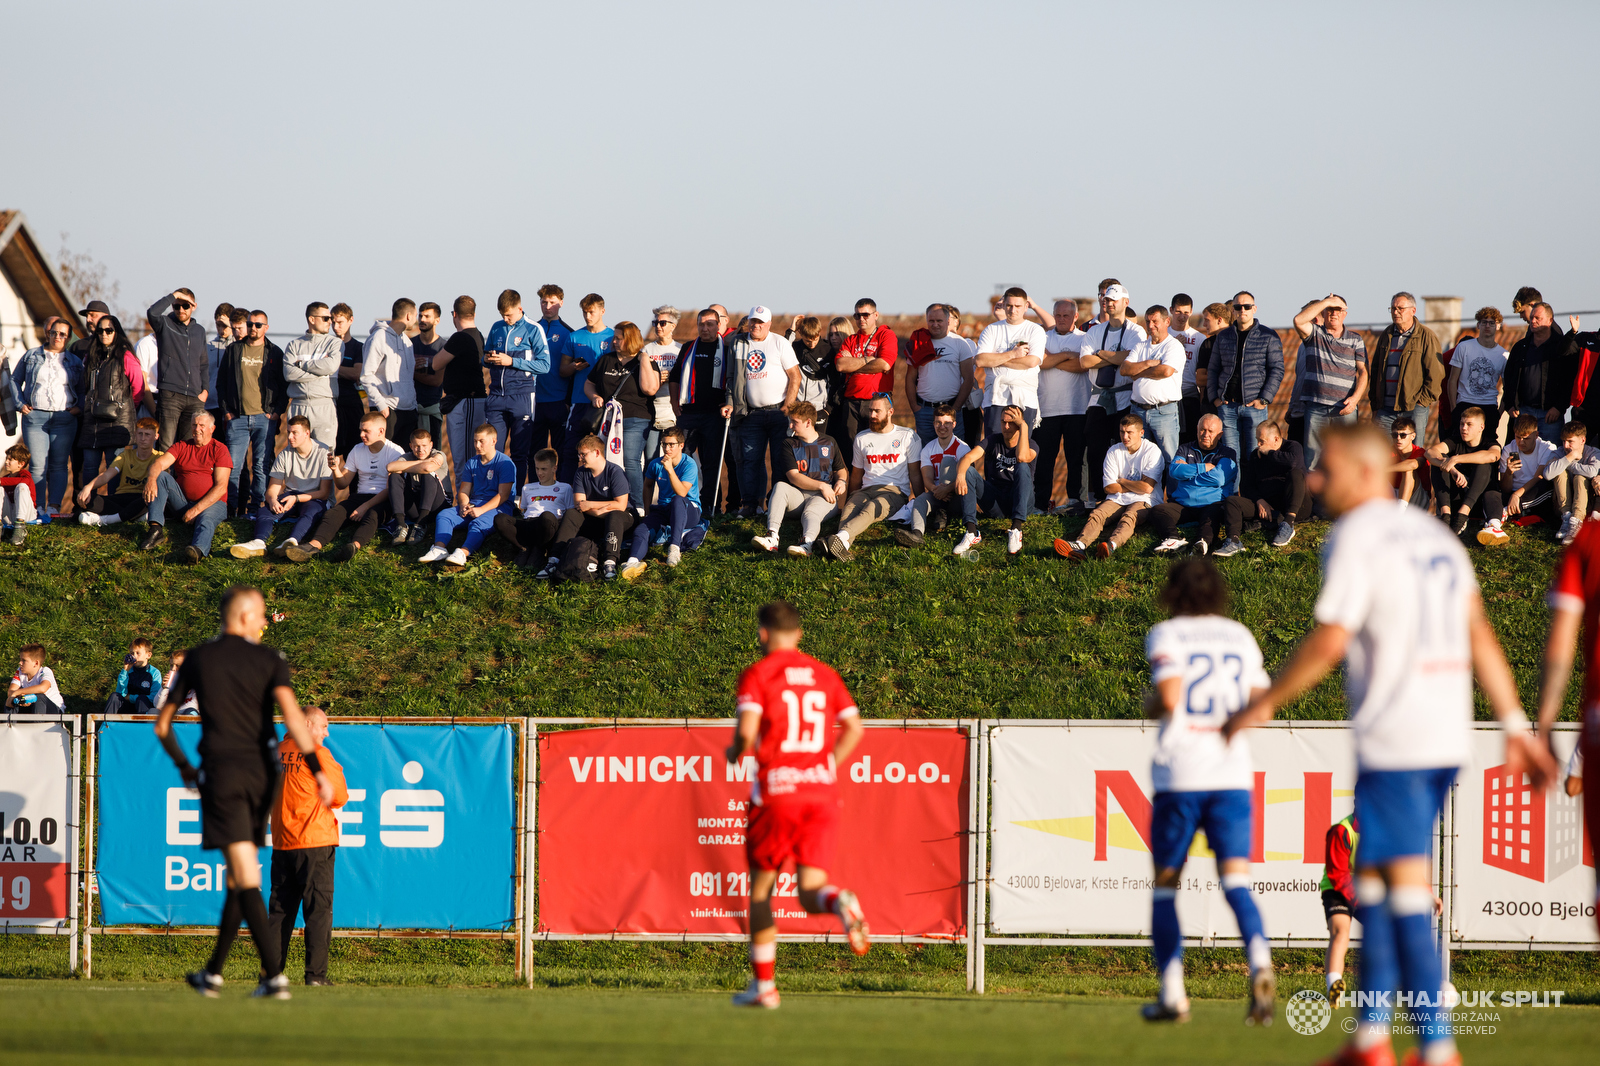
1144,615,1272,792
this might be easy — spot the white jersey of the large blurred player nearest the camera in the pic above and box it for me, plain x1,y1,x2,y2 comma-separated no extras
1315,499,1478,770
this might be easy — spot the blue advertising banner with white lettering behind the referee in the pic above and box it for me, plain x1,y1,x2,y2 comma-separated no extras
94,722,517,930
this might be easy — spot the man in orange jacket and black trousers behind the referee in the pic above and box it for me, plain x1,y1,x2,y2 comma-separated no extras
267,707,350,984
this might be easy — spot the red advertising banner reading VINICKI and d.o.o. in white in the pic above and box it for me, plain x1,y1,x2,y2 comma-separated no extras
536,720,971,938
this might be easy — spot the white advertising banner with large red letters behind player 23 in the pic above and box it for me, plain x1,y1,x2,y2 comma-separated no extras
989,722,1355,938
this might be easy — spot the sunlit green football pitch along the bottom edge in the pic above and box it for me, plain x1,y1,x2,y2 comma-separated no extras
0,981,1600,1066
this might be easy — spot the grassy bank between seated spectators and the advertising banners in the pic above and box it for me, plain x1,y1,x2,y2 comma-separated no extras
0,517,1578,719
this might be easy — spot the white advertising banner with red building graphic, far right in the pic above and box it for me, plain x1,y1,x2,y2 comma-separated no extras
1451,727,1600,944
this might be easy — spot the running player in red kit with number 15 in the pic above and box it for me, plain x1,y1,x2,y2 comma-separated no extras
728,600,870,1007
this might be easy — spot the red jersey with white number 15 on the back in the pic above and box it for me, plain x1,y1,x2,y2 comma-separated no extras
736,651,858,804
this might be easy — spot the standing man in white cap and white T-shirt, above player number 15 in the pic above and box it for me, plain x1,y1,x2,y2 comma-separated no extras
723,306,800,519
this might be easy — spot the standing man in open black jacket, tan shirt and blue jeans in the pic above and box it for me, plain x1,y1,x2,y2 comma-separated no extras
216,311,290,519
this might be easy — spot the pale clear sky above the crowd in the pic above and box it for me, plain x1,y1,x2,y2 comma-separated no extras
0,0,1600,333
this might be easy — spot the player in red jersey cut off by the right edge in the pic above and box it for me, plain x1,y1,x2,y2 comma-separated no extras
1539,520,1600,925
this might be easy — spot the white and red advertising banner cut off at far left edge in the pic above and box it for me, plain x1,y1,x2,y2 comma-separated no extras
0,722,72,928
